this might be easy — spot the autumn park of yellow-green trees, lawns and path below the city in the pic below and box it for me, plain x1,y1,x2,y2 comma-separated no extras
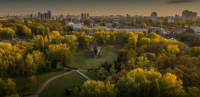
0,20,200,97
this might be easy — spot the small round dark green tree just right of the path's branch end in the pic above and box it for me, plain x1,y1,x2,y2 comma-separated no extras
97,68,110,81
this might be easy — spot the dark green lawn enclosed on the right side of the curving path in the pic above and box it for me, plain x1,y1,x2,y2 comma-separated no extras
39,72,87,97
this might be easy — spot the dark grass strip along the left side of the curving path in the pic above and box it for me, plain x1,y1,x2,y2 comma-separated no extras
12,70,67,95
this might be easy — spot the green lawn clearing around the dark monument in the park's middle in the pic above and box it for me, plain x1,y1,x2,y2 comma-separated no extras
71,45,121,70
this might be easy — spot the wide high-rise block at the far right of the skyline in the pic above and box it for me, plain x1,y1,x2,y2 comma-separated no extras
182,10,197,20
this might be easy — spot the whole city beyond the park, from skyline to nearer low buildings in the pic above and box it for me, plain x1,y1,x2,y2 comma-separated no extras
0,10,200,35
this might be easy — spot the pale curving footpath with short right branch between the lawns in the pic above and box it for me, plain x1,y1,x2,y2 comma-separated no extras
26,70,91,97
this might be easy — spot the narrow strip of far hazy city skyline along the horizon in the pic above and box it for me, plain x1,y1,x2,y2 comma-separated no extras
0,10,200,22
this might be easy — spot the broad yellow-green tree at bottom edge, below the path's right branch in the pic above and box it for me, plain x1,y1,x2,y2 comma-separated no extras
80,80,117,97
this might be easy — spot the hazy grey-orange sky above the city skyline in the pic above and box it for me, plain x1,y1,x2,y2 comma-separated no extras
0,0,200,16
